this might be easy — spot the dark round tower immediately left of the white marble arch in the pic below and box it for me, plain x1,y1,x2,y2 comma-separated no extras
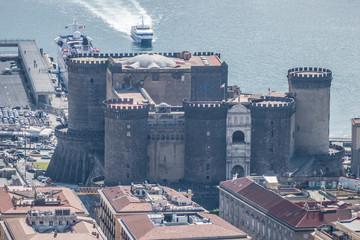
183,101,228,184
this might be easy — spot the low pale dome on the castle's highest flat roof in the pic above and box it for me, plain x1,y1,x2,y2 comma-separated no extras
122,54,176,69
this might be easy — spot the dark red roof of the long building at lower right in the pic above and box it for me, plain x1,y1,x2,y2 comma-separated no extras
220,177,351,228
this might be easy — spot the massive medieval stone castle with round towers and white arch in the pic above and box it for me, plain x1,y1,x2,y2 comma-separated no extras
47,51,343,186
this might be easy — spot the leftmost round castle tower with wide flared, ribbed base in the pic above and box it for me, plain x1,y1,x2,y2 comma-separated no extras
46,56,107,184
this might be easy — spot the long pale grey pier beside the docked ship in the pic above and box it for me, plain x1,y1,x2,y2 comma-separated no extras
0,40,54,104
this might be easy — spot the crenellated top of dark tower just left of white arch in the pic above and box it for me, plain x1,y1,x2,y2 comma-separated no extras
183,100,229,120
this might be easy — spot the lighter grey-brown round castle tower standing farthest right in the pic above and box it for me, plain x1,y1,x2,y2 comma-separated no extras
288,67,332,155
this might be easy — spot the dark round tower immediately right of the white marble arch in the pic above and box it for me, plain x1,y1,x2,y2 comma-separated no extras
250,97,295,175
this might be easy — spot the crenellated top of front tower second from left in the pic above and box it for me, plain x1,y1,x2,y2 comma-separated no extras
103,98,149,119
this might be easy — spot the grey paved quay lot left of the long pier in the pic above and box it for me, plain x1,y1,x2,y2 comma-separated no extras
0,61,30,107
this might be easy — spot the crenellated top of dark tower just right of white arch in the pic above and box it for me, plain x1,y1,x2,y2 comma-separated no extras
250,96,295,118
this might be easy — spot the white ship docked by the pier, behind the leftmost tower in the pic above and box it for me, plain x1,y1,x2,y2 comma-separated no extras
55,18,100,91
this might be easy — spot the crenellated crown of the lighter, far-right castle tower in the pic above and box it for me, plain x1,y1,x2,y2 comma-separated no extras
287,67,332,89
